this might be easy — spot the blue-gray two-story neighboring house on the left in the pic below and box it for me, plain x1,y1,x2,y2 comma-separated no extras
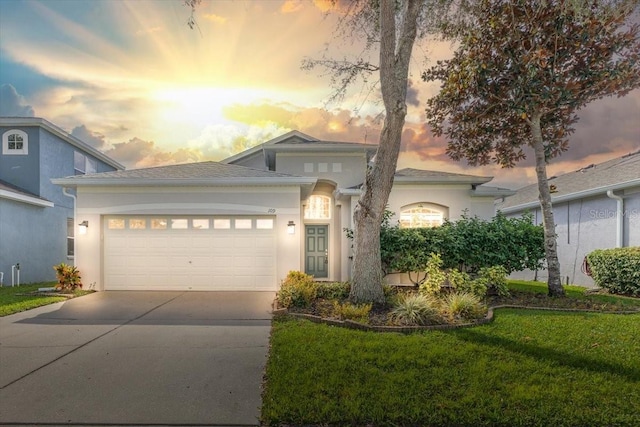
0,117,124,286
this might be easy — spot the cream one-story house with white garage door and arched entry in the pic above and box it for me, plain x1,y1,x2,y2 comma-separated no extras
53,131,513,291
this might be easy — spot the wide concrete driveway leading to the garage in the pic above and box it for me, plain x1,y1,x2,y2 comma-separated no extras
0,291,275,426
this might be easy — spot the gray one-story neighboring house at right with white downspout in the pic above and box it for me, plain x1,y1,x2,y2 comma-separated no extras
496,151,640,286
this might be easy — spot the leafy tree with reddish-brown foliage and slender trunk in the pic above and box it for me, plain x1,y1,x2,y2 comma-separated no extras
423,0,640,295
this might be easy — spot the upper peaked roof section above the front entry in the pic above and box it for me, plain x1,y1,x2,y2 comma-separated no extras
222,130,378,165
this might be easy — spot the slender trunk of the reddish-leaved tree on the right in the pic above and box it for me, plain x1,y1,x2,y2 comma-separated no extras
531,111,565,296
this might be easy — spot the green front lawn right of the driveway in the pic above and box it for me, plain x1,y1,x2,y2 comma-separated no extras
262,282,640,426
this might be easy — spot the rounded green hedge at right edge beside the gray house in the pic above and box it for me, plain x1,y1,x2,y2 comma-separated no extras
587,246,640,296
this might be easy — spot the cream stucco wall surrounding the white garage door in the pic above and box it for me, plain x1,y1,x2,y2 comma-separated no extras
76,186,303,290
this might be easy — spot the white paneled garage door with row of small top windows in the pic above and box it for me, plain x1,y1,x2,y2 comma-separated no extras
104,216,277,291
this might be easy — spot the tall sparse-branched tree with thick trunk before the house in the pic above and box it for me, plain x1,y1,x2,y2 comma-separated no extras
303,0,432,303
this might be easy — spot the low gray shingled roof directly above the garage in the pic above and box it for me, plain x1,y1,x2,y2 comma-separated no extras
52,162,316,187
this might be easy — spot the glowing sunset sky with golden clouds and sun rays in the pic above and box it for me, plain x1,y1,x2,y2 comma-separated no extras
0,0,640,189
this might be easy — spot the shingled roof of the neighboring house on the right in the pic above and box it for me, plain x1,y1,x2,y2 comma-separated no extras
501,150,640,213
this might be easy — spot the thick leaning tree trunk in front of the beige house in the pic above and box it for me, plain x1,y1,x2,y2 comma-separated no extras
350,0,423,303
